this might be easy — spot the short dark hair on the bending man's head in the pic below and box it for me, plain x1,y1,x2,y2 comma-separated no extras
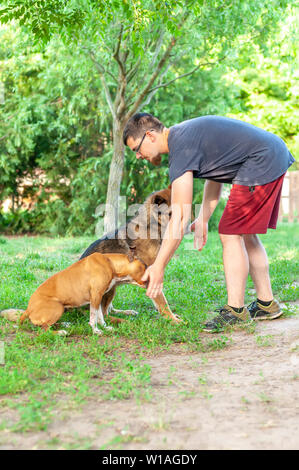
123,113,165,145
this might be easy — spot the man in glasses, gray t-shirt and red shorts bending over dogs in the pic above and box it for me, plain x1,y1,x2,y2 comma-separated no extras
123,113,294,332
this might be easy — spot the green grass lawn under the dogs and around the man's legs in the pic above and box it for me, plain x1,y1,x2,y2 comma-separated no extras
0,224,299,434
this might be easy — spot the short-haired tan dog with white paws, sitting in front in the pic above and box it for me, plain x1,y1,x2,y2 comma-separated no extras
20,253,145,334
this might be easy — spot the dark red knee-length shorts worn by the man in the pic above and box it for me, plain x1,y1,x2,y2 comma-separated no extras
218,175,284,235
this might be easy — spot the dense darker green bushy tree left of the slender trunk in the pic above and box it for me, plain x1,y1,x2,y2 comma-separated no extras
0,28,110,234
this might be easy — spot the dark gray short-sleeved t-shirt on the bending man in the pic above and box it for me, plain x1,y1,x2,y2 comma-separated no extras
168,116,295,186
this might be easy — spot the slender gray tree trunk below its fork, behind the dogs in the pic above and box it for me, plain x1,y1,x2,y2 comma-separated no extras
104,119,125,233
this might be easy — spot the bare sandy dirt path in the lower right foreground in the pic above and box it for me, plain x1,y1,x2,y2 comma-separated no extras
0,316,299,450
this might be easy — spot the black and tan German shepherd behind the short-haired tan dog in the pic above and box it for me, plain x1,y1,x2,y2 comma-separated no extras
80,186,181,323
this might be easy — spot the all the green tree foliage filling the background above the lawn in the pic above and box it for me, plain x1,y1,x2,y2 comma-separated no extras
0,0,298,235
